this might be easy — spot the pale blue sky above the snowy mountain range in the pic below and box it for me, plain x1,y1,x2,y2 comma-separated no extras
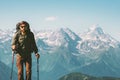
0,0,120,41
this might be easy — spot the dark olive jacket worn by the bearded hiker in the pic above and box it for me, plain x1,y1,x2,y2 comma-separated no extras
12,31,38,53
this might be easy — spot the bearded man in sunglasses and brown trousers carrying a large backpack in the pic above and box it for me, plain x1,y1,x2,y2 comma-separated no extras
12,21,40,80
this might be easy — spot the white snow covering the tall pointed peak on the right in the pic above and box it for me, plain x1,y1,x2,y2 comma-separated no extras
77,25,119,53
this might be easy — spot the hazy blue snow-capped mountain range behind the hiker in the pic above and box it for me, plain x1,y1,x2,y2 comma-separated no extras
0,26,120,80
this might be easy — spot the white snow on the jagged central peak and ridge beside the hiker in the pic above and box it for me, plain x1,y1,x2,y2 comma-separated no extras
36,28,79,46
